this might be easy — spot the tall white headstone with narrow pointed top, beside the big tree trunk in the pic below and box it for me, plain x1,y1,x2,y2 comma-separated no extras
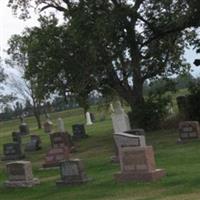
111,101,131,133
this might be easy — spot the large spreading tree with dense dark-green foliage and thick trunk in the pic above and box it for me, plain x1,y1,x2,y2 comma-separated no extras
8,0,200,128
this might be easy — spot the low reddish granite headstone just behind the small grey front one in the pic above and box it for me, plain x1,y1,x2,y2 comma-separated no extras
43,147,70,168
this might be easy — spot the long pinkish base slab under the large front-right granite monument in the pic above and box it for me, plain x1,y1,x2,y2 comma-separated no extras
114,169,165,182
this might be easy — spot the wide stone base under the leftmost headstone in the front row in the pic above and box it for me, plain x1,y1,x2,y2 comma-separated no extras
5,178,40,188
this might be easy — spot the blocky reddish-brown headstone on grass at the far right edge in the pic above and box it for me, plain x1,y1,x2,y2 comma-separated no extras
179,121,200,140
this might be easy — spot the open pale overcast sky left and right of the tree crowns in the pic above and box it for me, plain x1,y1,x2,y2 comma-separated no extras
0,0,200,76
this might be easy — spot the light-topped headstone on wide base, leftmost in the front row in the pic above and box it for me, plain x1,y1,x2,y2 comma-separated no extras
5,161,40,187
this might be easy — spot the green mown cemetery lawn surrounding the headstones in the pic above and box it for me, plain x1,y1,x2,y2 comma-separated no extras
0,109,200,200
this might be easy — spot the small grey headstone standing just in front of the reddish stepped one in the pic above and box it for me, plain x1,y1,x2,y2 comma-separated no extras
56,159,88,185
